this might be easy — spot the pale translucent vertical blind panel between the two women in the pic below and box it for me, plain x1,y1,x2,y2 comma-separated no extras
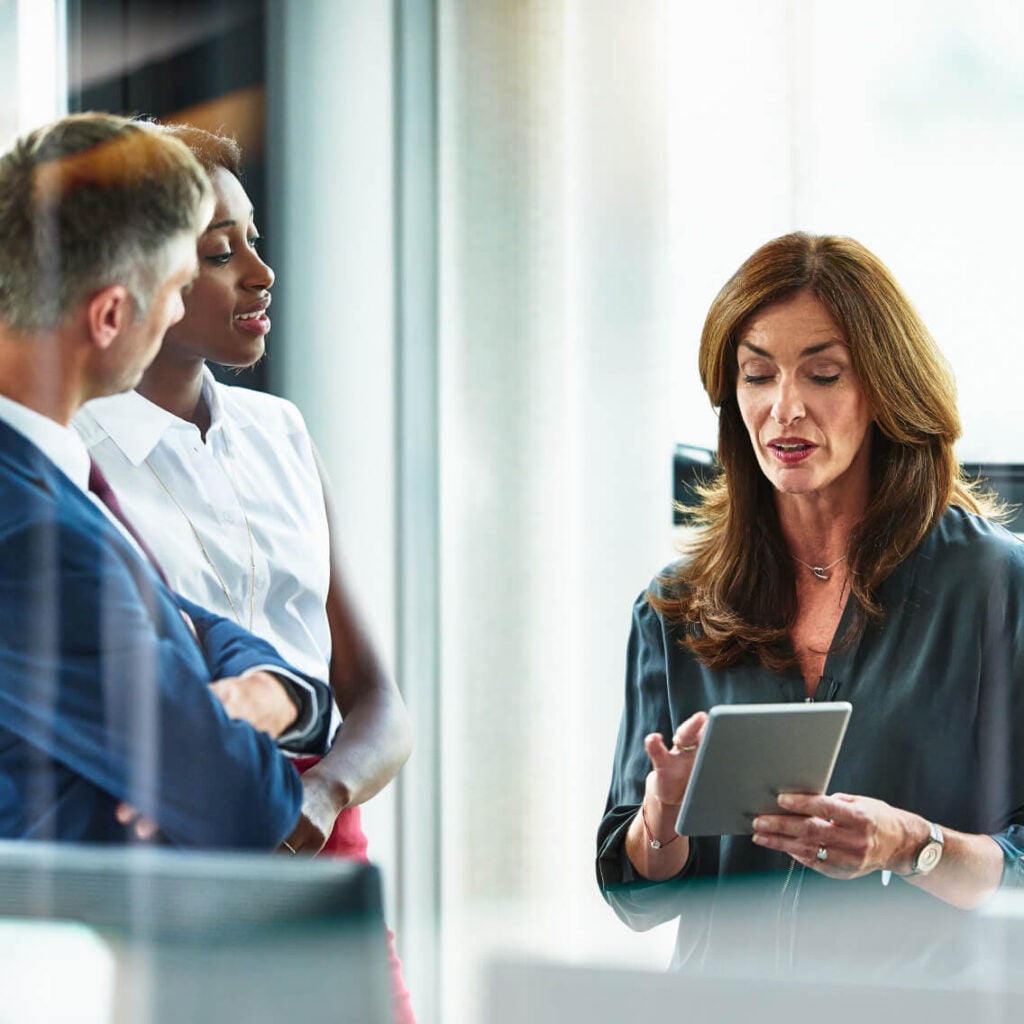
439,0,672,1021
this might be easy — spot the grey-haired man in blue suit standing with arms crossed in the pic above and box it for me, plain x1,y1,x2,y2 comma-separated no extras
0,114,330,849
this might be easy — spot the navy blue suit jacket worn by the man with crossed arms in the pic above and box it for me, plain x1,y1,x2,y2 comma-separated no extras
0,422,323,849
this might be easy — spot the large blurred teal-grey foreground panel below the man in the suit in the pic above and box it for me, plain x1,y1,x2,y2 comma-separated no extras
0,842,393,1024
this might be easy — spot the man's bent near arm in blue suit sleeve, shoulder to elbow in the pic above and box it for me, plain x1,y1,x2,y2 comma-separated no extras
0,520,301,848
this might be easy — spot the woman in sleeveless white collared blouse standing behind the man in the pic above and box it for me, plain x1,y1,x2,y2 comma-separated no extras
75,126,413,1021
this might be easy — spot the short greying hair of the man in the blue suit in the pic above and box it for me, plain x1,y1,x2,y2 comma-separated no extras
0,114,212,333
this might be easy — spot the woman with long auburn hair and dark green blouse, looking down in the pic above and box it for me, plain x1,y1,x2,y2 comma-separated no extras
597,233,1024,963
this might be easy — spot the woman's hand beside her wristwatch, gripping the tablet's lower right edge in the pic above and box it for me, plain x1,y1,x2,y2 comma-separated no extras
754,793,929,879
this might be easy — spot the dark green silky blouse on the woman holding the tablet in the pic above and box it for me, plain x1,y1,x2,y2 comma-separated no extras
597,508,1024,965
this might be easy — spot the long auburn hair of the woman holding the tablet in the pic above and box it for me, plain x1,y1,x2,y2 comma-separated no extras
648,231,1000,670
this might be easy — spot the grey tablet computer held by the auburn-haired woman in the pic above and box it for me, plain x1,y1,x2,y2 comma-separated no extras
676,700,852,836
